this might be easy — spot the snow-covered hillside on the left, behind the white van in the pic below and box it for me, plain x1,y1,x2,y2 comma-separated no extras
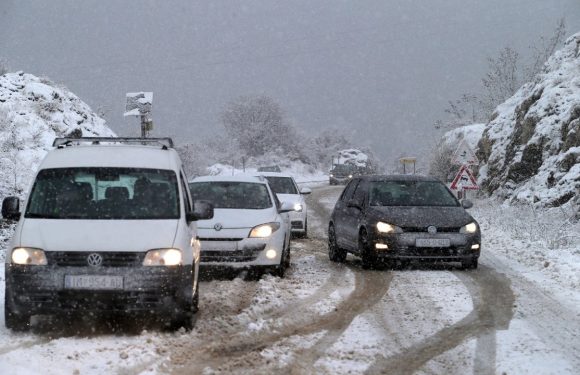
0,72,115,197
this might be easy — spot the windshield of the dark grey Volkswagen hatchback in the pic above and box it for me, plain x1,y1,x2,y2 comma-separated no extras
369,181,459,207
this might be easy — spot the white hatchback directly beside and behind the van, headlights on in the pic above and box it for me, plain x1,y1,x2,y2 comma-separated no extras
189,176,293,277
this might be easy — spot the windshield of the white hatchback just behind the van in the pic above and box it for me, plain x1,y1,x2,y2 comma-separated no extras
189,181,272,210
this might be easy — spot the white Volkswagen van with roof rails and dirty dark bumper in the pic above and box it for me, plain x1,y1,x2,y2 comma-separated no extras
2,138,213,330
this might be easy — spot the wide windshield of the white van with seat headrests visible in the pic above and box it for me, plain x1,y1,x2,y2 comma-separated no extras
24,167,179,220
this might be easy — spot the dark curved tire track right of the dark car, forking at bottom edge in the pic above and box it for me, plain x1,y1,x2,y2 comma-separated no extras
366,266,515,374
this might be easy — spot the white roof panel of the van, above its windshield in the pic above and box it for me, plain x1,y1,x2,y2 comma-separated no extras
40,144,181,170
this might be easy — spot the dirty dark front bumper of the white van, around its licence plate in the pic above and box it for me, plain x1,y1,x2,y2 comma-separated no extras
5,264,195,315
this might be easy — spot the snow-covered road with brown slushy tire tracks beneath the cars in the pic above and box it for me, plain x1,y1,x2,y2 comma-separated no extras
0,187,580,374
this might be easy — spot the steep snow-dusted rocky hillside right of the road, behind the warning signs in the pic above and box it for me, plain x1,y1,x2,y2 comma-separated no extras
477,33,580,206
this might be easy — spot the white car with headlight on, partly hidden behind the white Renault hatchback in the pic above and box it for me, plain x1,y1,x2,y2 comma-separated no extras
260,172,312,238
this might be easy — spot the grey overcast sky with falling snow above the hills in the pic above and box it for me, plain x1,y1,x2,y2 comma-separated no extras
0,0,580,164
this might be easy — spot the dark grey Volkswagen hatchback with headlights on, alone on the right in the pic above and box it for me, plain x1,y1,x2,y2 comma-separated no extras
328,175,481,269
